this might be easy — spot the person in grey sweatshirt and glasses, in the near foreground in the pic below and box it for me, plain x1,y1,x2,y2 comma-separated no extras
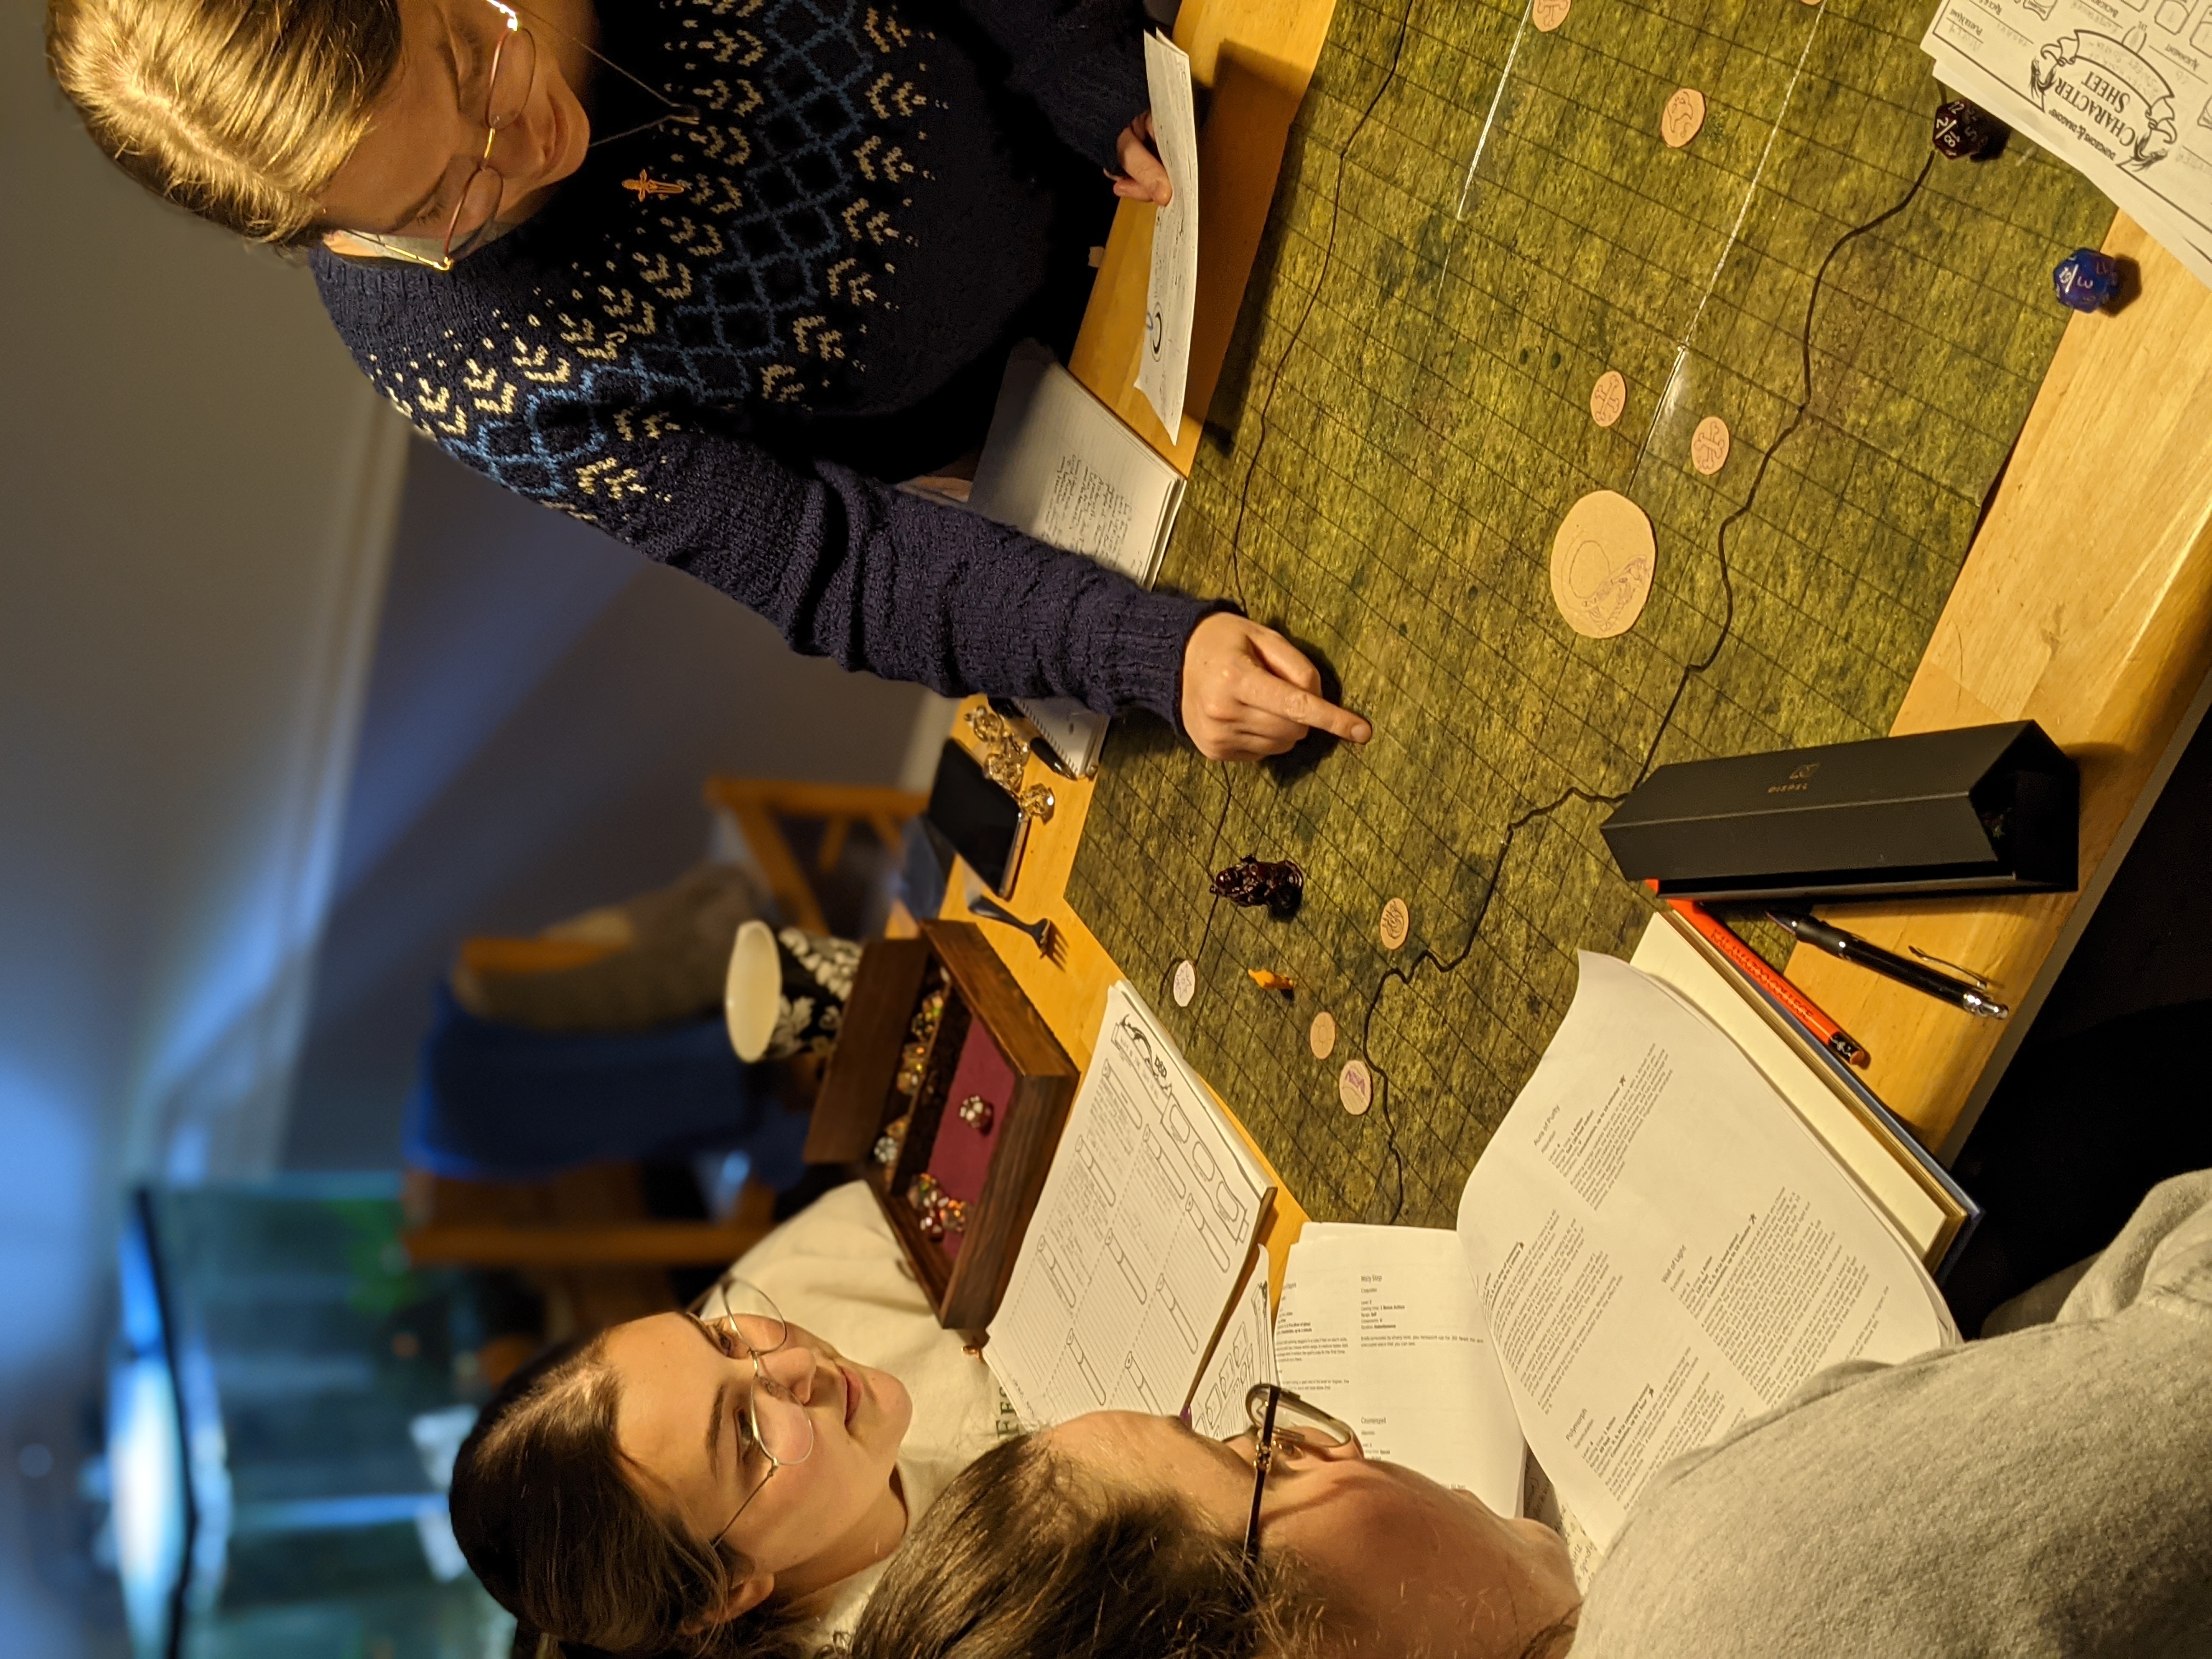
849,1170,2212,1659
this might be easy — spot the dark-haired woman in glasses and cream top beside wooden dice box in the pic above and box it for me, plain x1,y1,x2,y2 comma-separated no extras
452,1181,1013,1659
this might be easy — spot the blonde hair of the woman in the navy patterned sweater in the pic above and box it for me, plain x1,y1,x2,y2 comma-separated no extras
47,0,400,244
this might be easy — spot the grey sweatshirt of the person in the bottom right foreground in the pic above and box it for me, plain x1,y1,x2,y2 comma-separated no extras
1573,1170,2212,1659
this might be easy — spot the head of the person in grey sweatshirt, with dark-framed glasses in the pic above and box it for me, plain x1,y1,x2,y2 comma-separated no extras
849,1385,1582,1659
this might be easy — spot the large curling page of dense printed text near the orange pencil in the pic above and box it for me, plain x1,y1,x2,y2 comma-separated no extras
1460,951,1957,1546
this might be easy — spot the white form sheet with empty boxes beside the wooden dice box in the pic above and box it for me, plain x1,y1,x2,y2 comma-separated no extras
984,980,1274,1427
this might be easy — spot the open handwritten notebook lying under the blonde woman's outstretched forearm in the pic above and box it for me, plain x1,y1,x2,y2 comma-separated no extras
967,343,1183,776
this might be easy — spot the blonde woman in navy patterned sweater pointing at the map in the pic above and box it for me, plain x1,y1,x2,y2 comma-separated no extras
47,0,1369,759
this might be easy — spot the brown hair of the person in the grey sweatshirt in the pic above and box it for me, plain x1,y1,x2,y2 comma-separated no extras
851,1436,1323,1659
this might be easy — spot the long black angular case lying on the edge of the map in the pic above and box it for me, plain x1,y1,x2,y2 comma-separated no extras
1601,721,2081,900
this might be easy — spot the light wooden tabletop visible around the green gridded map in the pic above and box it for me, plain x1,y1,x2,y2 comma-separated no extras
945,0,2212,1157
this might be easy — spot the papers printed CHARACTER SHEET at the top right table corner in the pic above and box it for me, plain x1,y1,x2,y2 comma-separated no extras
1920,0,2212,283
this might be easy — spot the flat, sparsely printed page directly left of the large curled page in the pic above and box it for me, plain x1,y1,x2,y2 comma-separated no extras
1274,1221,1526,1515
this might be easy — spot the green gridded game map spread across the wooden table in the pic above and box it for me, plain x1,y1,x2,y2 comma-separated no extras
1068,0,2113,1223
